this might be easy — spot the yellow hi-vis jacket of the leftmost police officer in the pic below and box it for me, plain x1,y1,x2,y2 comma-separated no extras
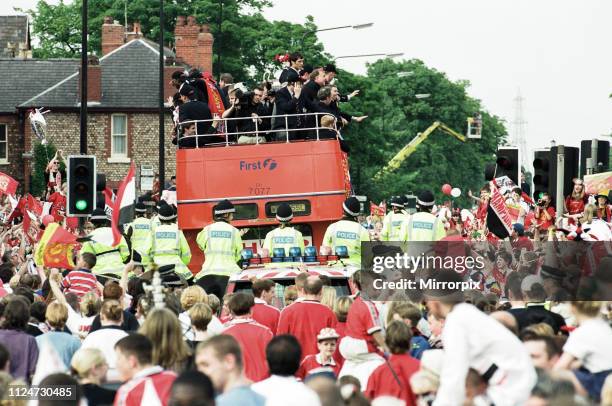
81,227,130,278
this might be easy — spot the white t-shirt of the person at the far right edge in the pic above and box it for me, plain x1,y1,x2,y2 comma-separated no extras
563,318,612,373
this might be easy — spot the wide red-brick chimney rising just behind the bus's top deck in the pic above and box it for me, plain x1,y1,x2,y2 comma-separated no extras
174,16,214,72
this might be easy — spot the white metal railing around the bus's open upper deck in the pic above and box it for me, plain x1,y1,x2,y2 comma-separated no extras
177,113,342,148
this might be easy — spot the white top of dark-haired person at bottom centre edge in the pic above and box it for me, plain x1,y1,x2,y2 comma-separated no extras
251,375,321,406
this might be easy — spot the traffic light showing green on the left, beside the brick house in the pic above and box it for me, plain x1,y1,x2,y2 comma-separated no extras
66,155,96,217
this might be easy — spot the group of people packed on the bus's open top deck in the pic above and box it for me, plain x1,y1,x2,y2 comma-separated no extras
169,52,367,148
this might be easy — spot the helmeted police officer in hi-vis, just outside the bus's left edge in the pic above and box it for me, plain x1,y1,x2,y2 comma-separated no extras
149,204,193,281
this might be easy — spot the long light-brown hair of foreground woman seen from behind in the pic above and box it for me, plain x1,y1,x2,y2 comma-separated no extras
138,309,191,370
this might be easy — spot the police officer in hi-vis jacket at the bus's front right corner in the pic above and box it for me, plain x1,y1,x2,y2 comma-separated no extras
323,196,370,267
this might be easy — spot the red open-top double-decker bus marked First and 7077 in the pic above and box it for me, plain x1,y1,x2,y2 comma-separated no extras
176,133,350,272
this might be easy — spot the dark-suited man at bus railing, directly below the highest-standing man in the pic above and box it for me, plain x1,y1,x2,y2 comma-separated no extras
272,72,302,141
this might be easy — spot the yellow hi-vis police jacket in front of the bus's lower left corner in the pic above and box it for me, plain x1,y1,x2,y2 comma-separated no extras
196,221,242,279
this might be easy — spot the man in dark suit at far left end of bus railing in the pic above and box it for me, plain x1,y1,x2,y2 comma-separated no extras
179,84,220,148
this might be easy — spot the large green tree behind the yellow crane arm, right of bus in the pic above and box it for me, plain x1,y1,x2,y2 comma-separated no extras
339,59,506,203
